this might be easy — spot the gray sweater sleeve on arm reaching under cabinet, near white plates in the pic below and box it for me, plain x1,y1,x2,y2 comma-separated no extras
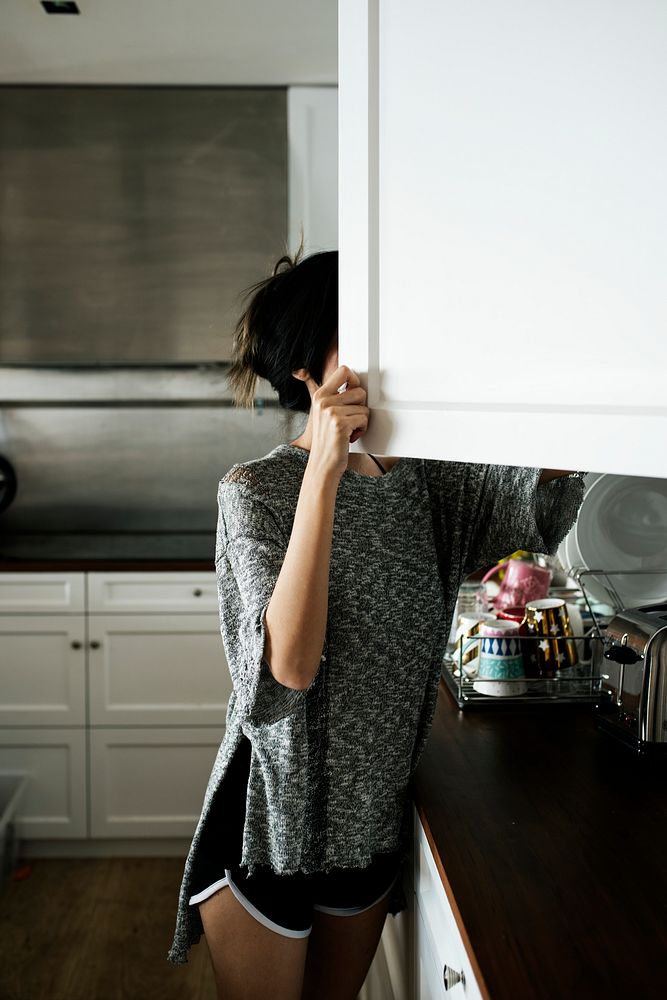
425,460,585,579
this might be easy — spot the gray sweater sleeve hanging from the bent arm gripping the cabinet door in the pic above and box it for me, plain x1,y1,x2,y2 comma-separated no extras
215,470,326,724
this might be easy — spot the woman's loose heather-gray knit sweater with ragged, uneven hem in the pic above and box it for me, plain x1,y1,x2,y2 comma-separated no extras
167,444,583,963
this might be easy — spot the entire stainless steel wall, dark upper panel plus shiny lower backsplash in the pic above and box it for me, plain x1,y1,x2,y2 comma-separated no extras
0,86,305,551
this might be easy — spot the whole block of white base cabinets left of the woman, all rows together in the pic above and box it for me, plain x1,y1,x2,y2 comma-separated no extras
0,571,226,840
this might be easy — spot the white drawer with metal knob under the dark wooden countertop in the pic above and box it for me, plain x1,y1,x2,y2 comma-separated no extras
414,809,482,1000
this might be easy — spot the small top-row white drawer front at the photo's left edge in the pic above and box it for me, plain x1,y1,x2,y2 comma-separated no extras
0,573,85,614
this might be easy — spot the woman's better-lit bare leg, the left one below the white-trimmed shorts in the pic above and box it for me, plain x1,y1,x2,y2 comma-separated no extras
199,886,308,1000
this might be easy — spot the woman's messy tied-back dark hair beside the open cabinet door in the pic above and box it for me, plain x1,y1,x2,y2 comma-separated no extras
227,241,338,413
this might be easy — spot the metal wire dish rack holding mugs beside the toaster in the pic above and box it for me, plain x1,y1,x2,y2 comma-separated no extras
442,567,667,709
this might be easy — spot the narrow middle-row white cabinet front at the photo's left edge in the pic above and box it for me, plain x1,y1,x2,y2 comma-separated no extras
0,614,86,726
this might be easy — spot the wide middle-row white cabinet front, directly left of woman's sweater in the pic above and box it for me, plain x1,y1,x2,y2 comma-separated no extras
88,613,232,726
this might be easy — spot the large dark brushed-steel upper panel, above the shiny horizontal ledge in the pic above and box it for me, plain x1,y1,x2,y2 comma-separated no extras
0,86,287,363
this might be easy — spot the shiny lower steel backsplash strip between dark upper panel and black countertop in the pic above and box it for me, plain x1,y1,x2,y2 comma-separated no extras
0,364,307,534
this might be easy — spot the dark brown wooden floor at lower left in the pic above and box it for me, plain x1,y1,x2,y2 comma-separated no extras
0,858,215,1000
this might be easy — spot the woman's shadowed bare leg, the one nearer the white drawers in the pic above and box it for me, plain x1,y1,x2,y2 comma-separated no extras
302,895,389,1000
